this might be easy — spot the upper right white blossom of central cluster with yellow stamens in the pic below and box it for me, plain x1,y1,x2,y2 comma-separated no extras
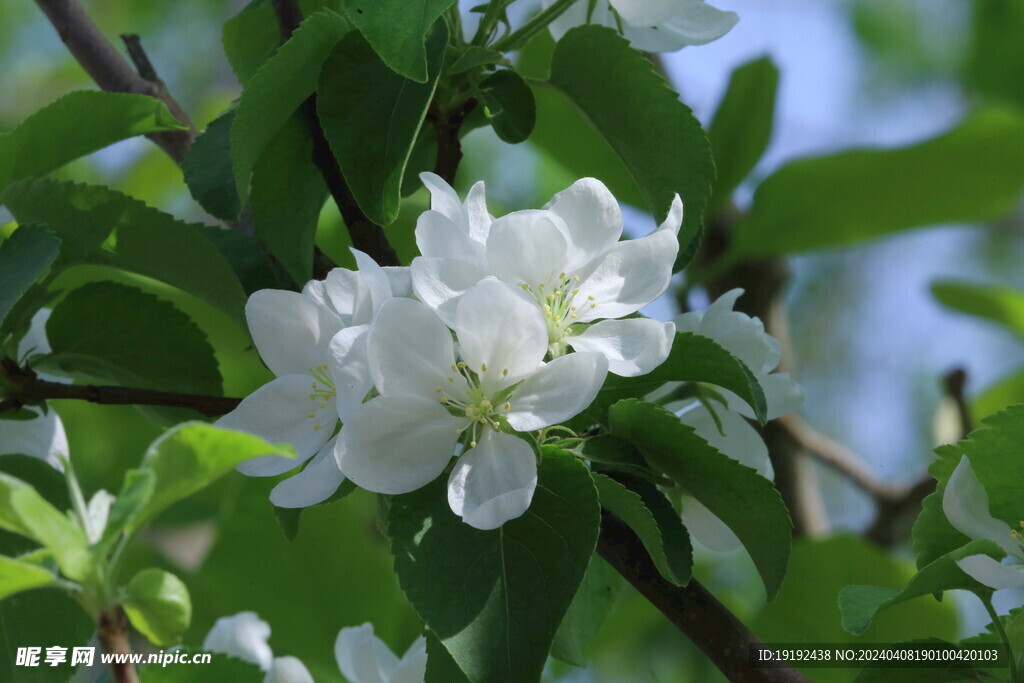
412,173,683,377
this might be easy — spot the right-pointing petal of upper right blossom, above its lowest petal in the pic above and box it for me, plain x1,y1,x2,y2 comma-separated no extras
574,230,679,323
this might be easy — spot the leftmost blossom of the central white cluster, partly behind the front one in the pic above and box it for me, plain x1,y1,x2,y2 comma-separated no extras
217,249,410,508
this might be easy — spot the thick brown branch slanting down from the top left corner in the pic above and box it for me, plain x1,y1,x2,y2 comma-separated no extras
36,0,196,164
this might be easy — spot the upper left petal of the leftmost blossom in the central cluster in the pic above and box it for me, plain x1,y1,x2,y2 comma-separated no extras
246,290,341,377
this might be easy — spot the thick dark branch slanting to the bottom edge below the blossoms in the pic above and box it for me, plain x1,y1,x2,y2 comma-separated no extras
597,511,808,683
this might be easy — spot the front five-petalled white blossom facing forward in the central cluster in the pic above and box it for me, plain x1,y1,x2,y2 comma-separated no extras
336,279,607,529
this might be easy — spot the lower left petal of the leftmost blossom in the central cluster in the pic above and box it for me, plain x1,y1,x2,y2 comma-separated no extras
216,375,338,476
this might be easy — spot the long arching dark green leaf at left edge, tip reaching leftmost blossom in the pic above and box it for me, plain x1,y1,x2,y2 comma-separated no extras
4,178,246,326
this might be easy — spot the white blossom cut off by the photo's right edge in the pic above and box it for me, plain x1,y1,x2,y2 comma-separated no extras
942,456,1024,590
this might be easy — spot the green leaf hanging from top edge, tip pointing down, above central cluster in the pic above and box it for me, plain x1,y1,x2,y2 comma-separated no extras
345,0,455,83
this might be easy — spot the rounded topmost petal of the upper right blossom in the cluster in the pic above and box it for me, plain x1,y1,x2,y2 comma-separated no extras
544,178,623,272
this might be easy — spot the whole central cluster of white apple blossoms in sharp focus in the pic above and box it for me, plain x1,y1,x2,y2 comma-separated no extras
218,174,682,529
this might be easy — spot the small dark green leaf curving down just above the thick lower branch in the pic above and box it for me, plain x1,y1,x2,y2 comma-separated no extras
593,472,693,586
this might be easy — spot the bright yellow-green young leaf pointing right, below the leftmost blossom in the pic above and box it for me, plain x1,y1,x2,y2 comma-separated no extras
132,422,295,532
